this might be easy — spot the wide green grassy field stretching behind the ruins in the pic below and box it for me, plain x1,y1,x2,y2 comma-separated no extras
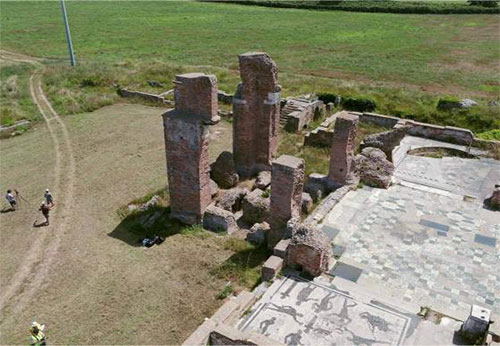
0,1,500,133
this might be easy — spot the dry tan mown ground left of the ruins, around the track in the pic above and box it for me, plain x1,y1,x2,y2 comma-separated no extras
0,104,233,344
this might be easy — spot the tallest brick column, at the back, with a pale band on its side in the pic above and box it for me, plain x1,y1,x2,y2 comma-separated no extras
233,52,281,177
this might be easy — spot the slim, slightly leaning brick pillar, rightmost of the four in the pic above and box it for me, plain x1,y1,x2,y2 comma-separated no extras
328,112,359,184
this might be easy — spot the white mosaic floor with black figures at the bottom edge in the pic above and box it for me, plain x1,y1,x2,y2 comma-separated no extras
239,277,418,345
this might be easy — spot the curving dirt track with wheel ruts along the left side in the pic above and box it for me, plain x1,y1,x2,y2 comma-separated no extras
0,50,76,315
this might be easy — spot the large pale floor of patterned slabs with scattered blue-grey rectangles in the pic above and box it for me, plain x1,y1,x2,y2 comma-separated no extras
323,185,500,318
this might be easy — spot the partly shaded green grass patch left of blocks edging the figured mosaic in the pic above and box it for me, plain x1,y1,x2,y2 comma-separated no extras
210,238,271,289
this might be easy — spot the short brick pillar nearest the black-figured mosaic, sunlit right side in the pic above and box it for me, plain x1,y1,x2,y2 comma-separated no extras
267,155,305,248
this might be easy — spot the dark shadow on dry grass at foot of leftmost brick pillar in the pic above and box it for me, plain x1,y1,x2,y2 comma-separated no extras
108,206,186,246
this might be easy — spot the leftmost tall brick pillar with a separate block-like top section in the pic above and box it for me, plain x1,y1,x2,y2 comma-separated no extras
163,73,217,224
